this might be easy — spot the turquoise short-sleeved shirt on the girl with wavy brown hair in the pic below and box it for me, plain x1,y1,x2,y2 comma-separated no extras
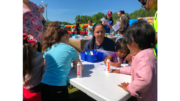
41,43,79,86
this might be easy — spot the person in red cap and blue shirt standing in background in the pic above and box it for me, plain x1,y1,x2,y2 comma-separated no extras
102,11,113,35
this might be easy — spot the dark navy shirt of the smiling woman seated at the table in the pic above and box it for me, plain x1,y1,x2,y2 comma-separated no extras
83,37,115,52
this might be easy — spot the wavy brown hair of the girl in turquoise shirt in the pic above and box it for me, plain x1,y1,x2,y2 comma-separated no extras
42,22,68,51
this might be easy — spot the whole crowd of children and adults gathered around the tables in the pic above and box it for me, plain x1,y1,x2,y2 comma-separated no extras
23,0,158,101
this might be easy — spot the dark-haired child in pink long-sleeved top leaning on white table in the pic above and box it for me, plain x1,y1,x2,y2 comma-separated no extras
112,21,157,101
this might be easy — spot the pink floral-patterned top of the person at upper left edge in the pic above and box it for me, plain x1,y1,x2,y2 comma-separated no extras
23,2,43,42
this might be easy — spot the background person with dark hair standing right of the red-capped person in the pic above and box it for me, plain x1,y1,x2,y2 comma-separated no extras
115,14,129,42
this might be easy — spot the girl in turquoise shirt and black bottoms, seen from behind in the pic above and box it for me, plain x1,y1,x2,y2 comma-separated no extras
41,22,83,101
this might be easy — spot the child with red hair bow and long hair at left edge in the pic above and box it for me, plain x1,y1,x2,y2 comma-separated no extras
23,34,44,93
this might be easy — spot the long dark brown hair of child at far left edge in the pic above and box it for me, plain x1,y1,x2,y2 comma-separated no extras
23,40,34,81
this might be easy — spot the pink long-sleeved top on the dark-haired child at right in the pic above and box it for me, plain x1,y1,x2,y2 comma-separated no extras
120,48,157,101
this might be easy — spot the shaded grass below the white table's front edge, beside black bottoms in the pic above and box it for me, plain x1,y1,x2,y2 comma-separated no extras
68,85,96,101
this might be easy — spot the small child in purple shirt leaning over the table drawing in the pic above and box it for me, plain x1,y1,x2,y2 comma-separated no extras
104,38,129,67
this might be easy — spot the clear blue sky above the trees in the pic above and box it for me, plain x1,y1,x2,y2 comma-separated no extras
30,0,141,23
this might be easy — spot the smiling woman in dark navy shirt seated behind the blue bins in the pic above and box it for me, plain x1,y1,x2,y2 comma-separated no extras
83,23,115,52
